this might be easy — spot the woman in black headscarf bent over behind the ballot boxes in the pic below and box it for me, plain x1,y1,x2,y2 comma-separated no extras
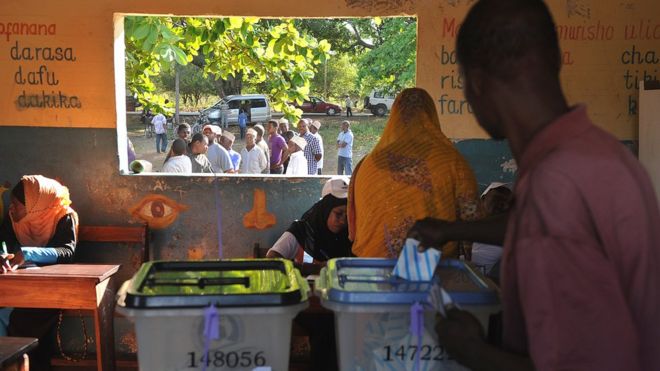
266,177,353,265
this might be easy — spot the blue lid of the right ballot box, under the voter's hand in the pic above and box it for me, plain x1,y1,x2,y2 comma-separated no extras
316,258,498,305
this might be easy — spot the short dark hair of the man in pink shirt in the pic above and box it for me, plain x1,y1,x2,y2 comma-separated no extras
456,0,561,79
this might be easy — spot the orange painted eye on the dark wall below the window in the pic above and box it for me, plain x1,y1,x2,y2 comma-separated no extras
128,194,188,229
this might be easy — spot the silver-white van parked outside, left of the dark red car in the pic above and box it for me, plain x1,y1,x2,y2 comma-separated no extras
202,94,271,124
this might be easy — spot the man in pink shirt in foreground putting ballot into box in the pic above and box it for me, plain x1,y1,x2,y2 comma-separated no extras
409,0,660,370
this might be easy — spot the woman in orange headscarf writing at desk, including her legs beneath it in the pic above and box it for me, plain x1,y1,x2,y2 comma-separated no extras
0,175,78,370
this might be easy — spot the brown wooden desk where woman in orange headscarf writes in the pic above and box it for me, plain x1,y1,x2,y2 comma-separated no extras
0,264,119,370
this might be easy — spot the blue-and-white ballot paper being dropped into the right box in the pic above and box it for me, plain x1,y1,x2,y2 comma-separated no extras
392,238,441,281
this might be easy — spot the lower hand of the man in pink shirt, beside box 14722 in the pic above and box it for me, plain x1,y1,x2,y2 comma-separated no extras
435,309,485,364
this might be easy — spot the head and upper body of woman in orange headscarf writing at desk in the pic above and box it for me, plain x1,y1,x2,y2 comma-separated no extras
0,175,78,272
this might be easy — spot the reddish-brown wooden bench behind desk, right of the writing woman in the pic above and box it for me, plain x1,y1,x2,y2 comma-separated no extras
51,224,151,370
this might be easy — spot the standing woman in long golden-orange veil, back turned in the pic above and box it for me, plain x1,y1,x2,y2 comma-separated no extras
348,88,482,257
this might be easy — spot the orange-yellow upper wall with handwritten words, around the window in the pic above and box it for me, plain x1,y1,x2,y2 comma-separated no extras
0,0,660,139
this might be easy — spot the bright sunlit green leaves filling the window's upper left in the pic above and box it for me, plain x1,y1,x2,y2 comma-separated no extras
124,16,330,116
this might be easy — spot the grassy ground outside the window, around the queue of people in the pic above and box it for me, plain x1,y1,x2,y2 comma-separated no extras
126,114,387,175
